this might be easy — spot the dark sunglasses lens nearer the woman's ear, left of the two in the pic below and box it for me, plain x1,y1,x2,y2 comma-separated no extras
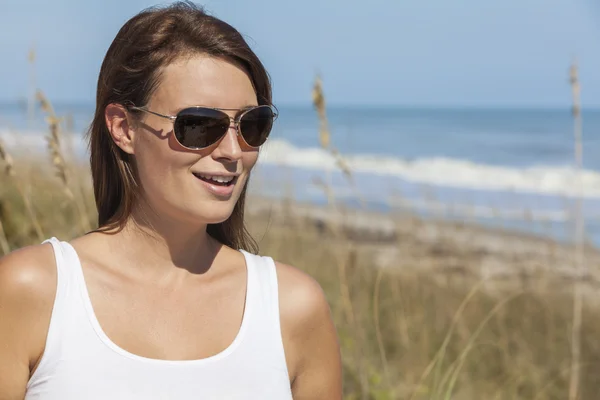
174,108,229,149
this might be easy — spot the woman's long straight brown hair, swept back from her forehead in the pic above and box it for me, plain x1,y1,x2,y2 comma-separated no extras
88,1,272,252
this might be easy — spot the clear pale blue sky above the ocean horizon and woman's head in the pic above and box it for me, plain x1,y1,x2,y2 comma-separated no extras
0,0,600,107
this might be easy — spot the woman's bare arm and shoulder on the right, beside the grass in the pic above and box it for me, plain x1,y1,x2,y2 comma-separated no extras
278,264,342,400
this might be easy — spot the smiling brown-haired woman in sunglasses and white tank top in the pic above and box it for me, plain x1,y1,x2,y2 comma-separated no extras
0,3,342,400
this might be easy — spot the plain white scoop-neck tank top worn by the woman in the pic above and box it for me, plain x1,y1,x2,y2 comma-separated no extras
25,238,292,400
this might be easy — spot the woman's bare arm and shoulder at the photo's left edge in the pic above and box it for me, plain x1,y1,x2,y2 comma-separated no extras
0,245,56,400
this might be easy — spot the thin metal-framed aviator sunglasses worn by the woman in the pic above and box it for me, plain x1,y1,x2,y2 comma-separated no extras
128,105,278,150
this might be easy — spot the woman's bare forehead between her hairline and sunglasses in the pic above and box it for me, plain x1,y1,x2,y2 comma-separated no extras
151,55,258,112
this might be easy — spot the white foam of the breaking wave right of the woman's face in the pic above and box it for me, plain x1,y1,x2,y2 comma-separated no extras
261,140,600,198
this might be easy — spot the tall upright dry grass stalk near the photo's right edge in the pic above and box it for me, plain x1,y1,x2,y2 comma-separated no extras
569,57,589,400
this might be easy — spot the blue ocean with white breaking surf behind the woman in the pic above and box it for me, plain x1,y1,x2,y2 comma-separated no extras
0,104,600,245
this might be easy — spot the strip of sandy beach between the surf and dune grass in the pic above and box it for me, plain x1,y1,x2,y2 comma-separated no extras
248,197,600,298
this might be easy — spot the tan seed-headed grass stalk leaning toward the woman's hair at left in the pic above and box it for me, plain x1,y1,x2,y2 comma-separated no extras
36,91,92,232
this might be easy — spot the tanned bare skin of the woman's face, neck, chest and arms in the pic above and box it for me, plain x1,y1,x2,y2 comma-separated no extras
0,56,342,400
